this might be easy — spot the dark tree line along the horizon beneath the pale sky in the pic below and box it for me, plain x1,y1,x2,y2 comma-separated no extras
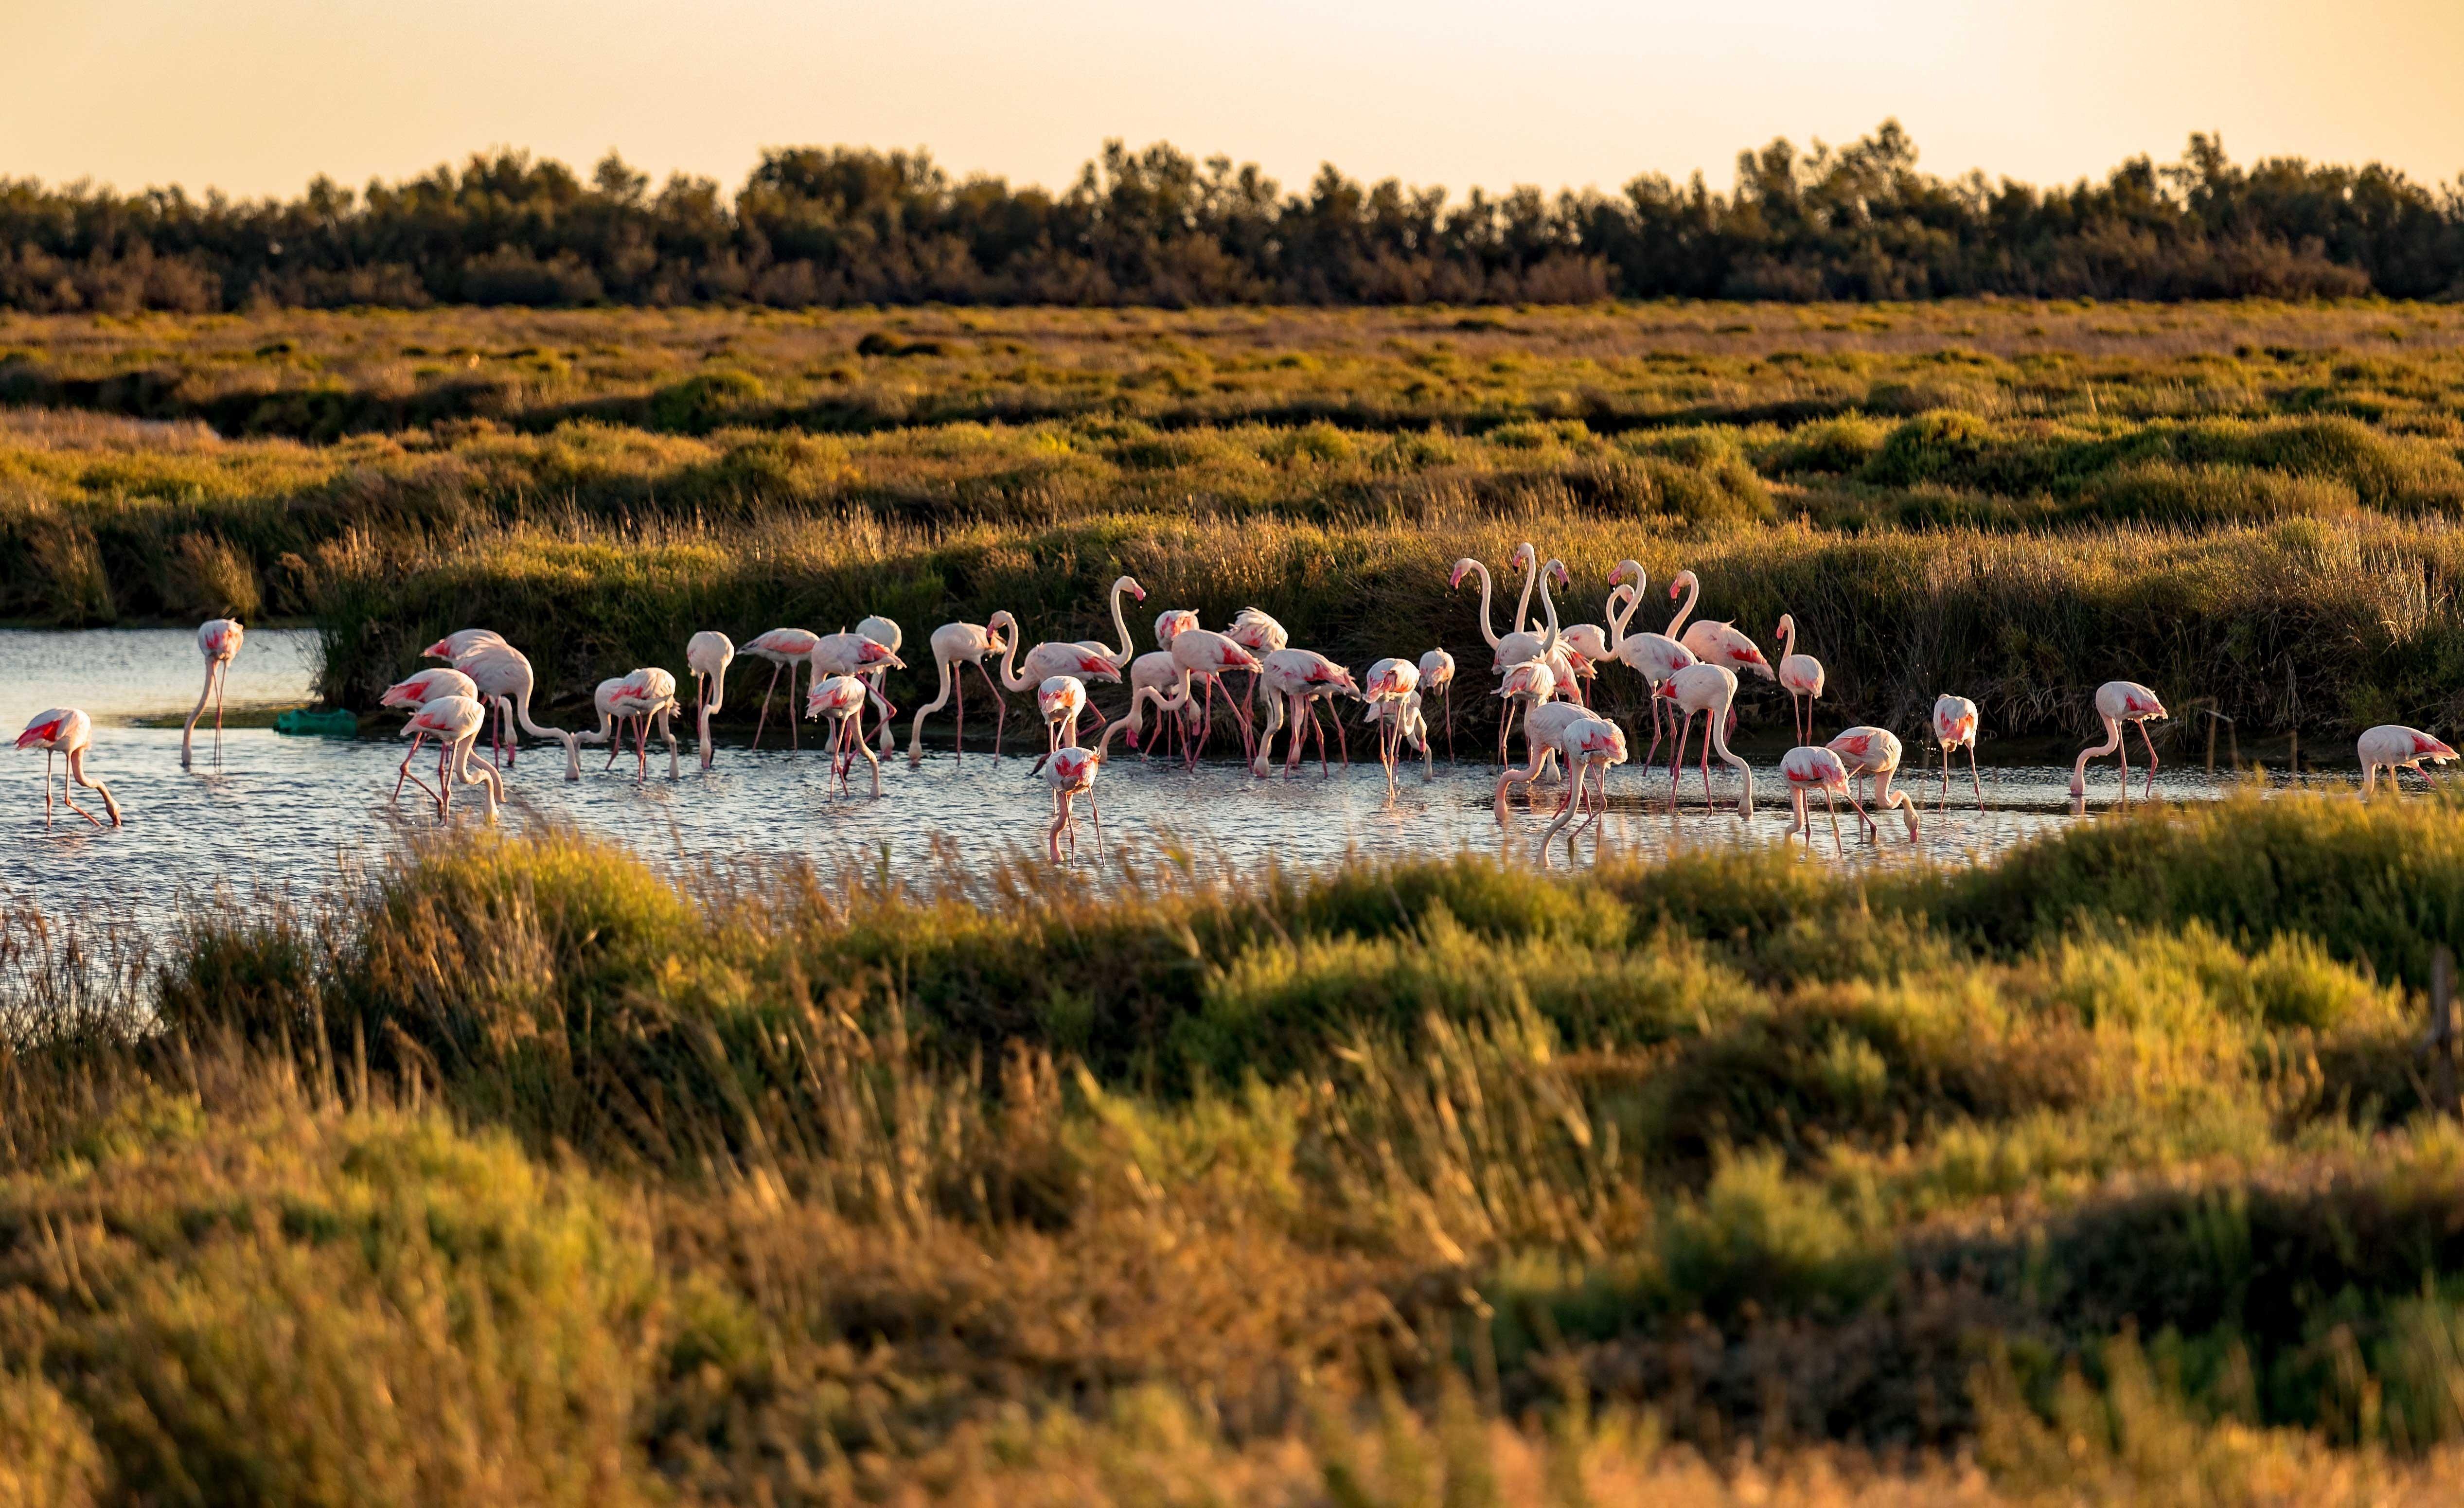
0,121,2464,313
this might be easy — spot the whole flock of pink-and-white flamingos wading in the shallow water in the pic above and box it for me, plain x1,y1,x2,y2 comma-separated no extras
17,545,2457,860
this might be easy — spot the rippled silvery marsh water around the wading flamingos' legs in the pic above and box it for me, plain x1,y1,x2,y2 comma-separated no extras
0,628,2326,924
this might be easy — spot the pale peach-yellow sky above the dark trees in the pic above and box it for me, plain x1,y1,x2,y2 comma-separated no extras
0,0,2464,195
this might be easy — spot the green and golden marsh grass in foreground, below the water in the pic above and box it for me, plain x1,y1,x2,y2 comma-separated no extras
0,798,2464,1503
